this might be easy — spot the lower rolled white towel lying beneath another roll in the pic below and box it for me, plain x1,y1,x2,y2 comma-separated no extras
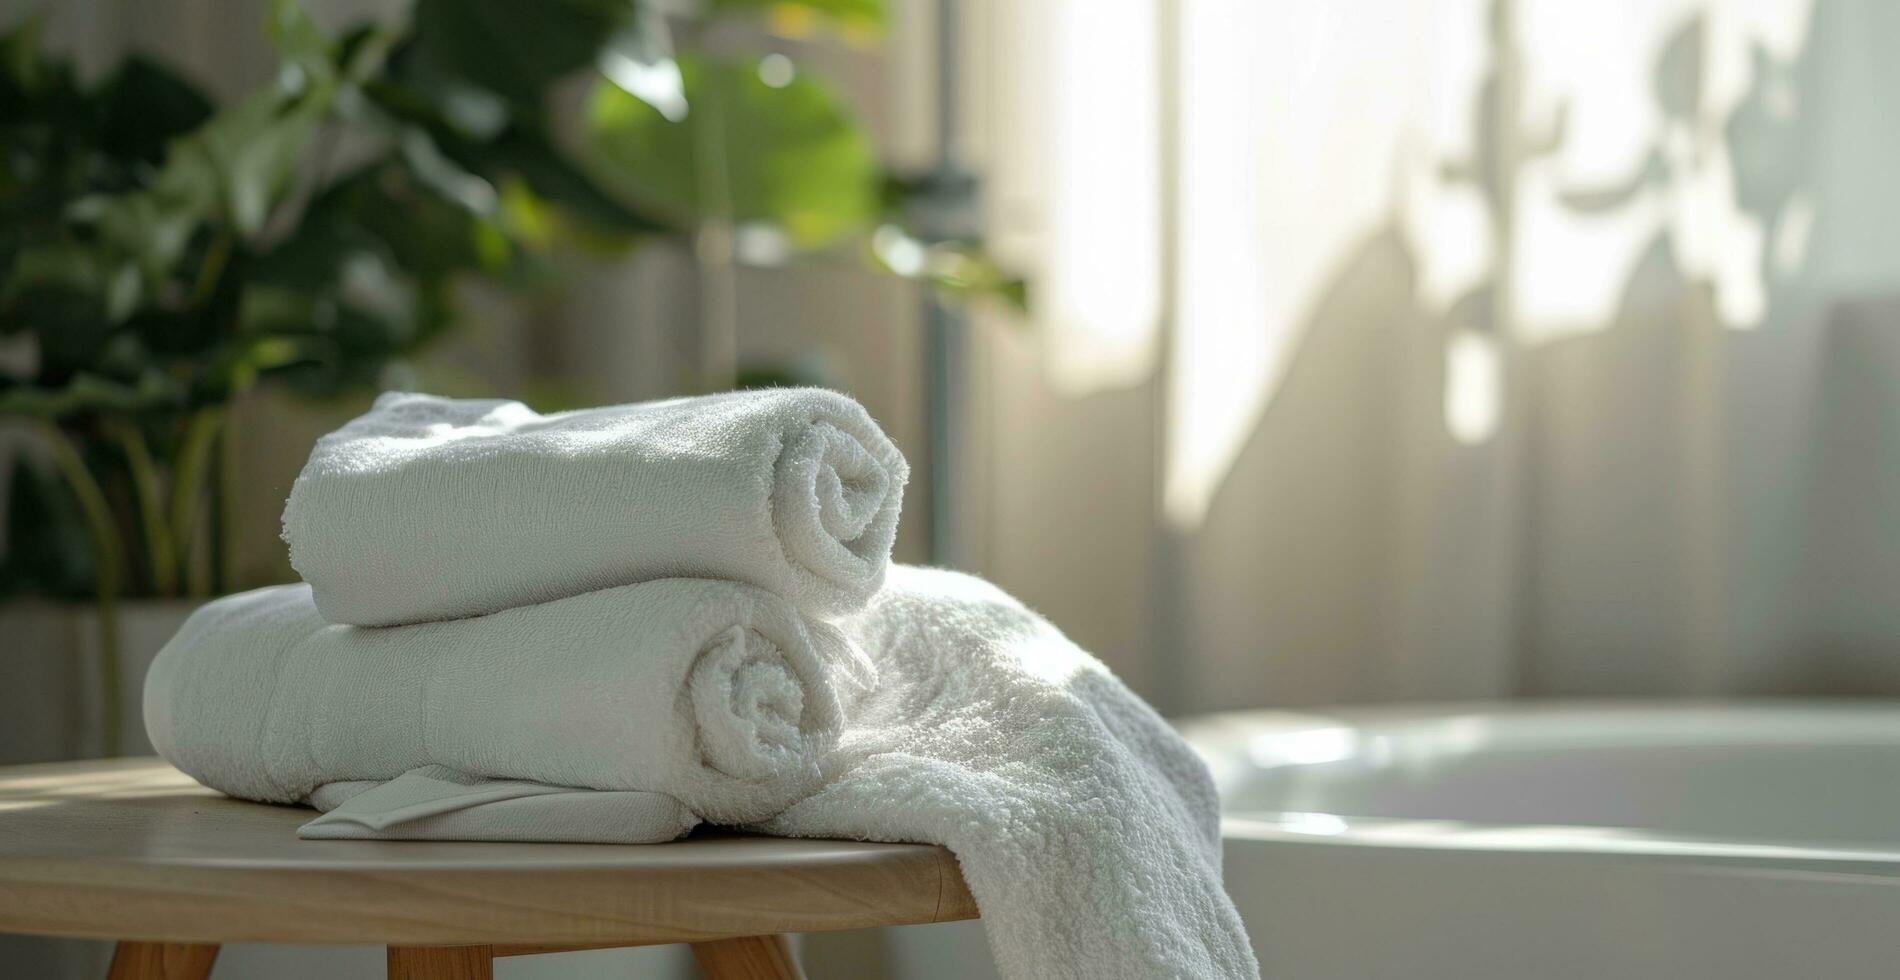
144,579,872,822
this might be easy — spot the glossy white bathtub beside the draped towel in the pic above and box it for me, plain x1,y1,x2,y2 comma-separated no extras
1184,703,1900,980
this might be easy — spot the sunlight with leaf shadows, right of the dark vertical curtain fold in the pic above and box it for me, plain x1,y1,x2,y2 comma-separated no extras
1511,0,1809,344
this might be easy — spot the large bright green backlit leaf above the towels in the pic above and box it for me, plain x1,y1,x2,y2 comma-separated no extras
587,57,878,247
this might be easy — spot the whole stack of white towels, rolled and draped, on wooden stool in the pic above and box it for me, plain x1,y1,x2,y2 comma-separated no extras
144,389,1258,978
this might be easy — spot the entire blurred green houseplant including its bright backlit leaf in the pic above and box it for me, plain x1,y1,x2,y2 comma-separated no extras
0,0,1020,750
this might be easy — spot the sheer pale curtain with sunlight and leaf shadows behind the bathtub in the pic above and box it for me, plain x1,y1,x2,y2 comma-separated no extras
957,0,1900,710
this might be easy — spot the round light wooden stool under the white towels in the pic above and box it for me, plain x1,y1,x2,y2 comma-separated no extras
0,760,977,980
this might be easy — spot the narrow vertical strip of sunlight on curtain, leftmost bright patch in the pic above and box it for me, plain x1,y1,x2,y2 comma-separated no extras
986,0,1163,395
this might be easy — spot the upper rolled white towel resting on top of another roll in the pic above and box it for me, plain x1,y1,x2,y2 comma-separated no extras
283,387,910,627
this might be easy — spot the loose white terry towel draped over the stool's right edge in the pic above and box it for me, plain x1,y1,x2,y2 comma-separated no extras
762,566,1260,980
